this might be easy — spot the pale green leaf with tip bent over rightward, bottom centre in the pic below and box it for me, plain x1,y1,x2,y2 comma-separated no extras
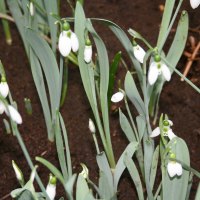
114,142,138,191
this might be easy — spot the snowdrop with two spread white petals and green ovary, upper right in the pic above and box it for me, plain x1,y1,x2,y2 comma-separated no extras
148,55,171,85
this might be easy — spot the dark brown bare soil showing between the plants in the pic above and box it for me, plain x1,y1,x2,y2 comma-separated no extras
0,0,200,200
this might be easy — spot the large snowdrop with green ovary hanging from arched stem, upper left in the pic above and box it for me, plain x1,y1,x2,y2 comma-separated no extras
58,22,79,57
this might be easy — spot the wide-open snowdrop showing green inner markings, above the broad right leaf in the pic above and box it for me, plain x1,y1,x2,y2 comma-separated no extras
150,120,176,140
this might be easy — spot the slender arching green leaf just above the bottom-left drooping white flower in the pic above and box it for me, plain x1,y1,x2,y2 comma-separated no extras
35,157,65,186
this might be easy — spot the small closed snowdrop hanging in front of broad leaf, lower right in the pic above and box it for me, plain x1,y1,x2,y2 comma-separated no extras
167,153,183,178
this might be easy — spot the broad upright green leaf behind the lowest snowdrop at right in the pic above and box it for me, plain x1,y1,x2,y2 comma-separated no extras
162,137,190,200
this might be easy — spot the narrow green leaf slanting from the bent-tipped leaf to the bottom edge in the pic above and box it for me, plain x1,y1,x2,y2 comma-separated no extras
124,154,144,200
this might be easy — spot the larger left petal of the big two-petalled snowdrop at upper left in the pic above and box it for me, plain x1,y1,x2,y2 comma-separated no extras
58,31,72,57
